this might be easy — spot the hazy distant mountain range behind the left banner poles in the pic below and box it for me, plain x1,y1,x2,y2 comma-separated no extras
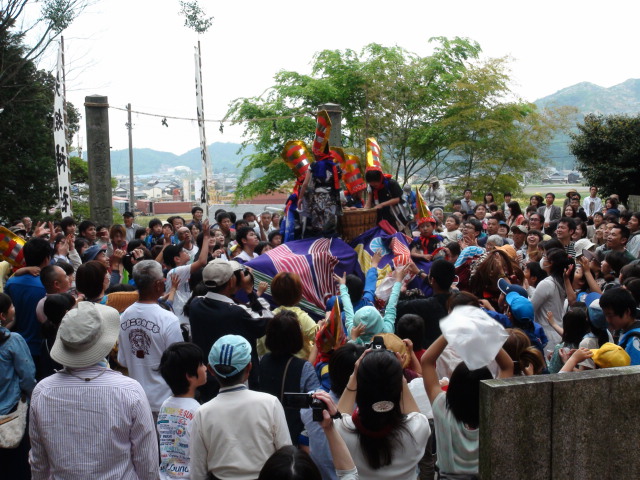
107,142,252,176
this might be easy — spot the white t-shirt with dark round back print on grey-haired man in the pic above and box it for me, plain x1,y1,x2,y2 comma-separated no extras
118,302,183,412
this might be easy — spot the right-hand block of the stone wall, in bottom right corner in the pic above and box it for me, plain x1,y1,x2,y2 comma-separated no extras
550,367,640,480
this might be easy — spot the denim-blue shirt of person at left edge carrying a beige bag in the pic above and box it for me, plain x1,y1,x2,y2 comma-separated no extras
0,327,36,415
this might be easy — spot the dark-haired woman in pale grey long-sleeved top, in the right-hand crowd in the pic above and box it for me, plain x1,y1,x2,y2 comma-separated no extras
531,248,574,348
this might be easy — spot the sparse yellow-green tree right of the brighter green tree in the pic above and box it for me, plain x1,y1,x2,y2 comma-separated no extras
441,58,571,195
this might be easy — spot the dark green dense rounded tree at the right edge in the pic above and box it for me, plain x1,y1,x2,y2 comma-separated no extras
570,114,640,205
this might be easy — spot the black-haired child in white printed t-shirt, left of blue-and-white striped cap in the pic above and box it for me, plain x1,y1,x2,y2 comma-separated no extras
158,342,207,480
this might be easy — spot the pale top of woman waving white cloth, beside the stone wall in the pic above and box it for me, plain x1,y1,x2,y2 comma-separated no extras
432,392,480,475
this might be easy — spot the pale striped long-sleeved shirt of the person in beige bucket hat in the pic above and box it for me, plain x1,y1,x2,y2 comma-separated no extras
29,365,158,480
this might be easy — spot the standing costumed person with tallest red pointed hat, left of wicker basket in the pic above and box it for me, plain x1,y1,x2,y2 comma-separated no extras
300,110,342,237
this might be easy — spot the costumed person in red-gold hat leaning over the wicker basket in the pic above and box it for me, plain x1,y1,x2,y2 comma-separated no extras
364,138,408,231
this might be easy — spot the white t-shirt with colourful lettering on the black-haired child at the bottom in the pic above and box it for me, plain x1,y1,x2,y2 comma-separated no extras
158,396,200,480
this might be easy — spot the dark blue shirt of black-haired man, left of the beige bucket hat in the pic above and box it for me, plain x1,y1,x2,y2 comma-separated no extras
5,275,47,356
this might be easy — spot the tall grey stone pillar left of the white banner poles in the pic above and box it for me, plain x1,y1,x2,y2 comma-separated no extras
84,95,113,225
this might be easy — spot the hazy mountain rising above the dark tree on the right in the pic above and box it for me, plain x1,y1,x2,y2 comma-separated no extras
534,78,640,170
